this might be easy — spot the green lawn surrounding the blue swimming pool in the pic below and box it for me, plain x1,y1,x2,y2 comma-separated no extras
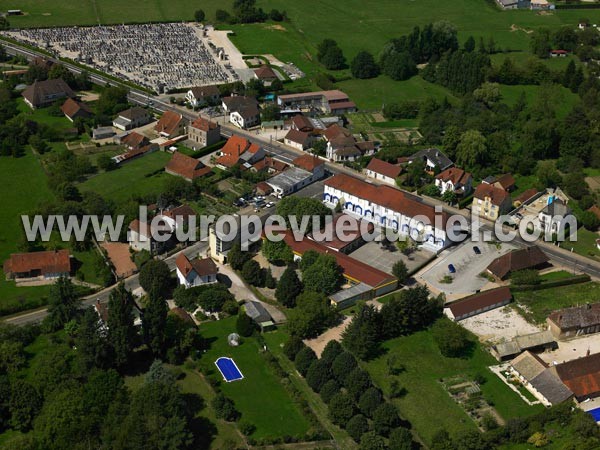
200,317,310,439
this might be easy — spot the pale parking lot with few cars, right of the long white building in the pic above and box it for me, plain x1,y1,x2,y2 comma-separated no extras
419,241,514,300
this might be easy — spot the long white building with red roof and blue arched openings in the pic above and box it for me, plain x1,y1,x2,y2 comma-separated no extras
323,174,459,252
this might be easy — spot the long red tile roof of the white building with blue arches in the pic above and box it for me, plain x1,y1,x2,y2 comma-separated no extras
325,174,449,226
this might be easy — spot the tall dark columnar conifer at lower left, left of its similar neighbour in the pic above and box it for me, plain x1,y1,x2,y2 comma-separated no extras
106,283,136,368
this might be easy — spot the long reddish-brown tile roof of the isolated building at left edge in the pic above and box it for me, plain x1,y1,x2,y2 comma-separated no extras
4,250,71,275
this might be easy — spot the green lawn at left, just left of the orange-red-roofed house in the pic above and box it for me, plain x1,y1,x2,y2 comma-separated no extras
79,151,171,202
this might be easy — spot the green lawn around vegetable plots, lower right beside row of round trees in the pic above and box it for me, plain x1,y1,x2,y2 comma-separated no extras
366,330,542,444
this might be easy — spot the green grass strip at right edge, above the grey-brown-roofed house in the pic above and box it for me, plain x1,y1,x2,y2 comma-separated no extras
513,282,600,323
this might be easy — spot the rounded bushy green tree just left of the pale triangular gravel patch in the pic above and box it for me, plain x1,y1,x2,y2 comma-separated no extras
288,292,338,339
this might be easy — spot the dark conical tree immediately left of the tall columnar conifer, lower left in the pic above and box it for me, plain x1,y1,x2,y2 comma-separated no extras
75,307,108,372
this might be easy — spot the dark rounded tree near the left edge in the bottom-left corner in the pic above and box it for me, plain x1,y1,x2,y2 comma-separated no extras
8,378,43,431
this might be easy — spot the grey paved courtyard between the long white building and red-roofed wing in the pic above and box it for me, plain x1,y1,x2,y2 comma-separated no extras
350,242,435,274
